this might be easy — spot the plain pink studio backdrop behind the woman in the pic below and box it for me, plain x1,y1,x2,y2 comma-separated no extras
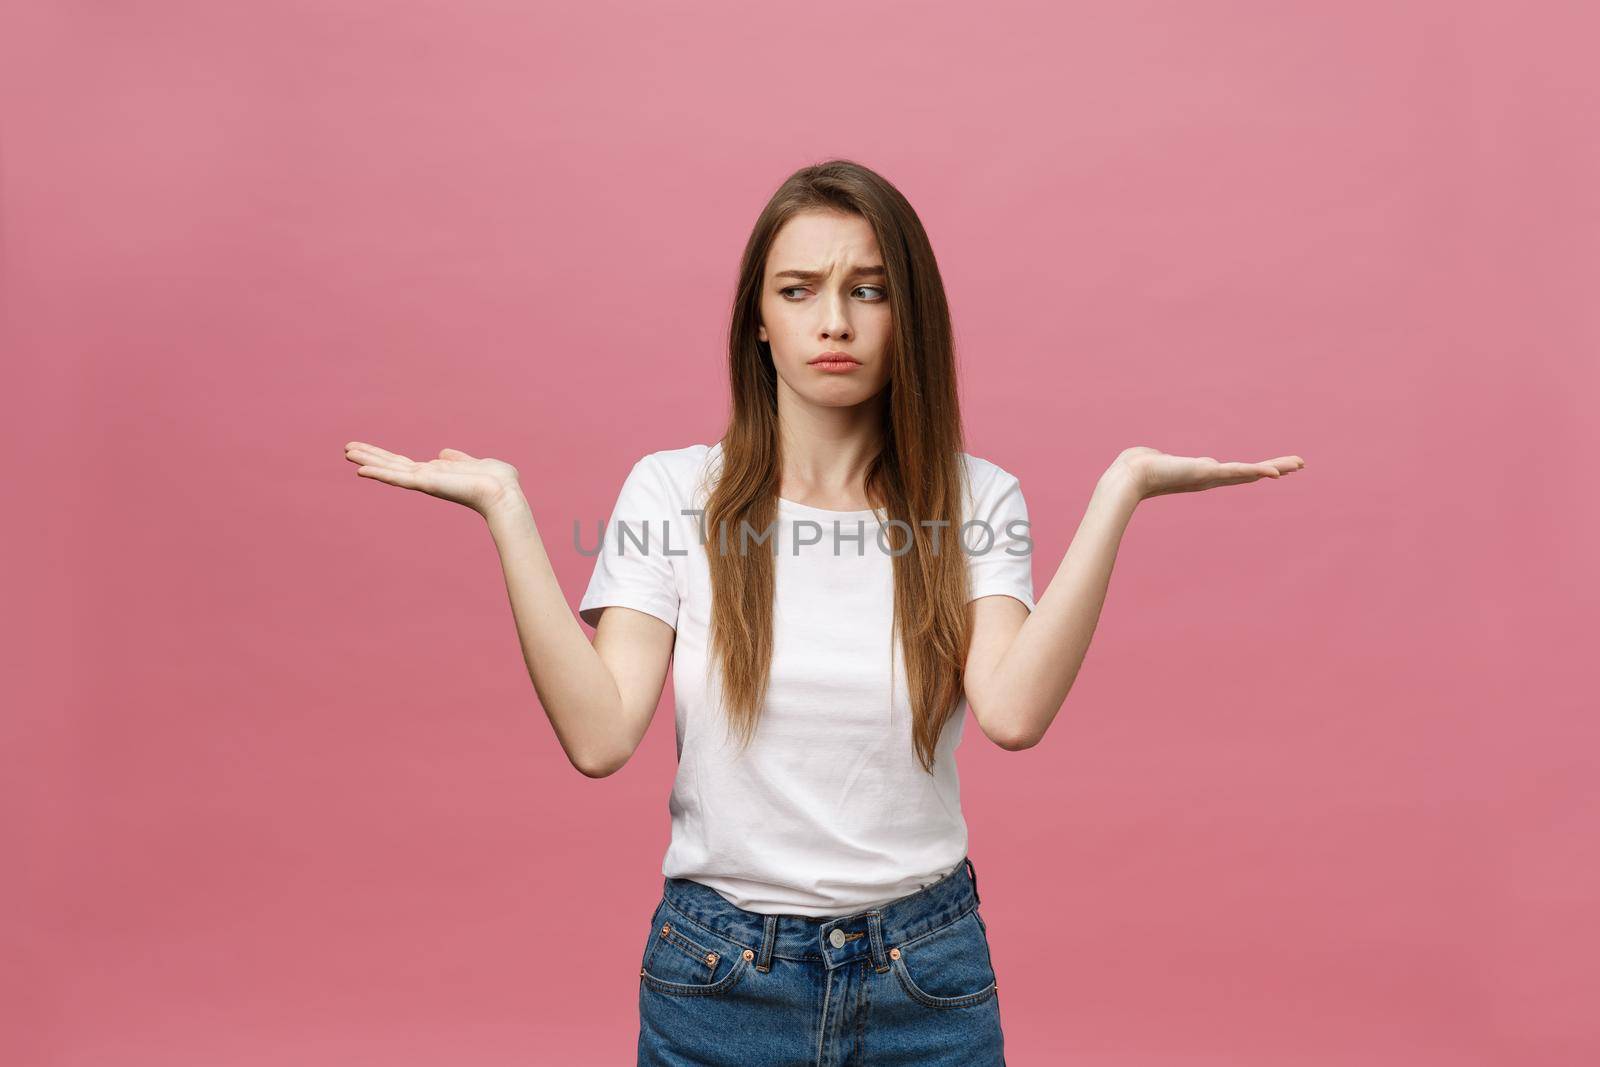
0,0,1600,1067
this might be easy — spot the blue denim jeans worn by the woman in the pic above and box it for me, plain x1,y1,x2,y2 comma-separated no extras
638,859,1005,1067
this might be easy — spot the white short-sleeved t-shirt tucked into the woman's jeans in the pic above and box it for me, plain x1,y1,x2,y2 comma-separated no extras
579,443,1034,917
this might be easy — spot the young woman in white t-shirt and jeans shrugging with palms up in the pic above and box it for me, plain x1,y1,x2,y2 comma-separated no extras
346,160,1304,1067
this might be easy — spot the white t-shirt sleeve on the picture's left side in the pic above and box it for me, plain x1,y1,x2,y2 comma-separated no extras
578,456,688,630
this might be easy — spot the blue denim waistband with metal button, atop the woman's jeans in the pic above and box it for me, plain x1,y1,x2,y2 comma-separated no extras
662,856,979,973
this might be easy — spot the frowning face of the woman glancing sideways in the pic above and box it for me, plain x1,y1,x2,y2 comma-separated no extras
757,211,893,408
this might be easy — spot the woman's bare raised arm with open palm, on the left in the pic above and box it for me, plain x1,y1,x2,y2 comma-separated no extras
346,442,675,777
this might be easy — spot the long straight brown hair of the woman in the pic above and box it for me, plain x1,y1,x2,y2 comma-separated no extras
704,160,971,774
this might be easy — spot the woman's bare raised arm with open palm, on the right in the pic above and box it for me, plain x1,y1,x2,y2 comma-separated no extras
965,448,1306,750
